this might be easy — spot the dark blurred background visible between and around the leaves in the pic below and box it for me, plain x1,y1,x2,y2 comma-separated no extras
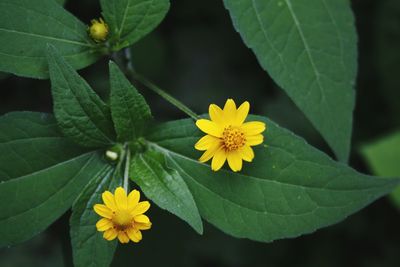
0,0,400,267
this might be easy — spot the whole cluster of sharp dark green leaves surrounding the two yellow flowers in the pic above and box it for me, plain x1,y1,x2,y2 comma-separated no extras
0,0,399,266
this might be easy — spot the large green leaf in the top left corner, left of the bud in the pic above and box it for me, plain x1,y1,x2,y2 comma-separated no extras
0,0,101,78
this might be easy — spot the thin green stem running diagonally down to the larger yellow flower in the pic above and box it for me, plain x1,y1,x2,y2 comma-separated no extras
124,49,199,120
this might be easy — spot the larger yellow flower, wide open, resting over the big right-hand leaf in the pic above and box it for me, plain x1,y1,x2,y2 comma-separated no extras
195,99,266,172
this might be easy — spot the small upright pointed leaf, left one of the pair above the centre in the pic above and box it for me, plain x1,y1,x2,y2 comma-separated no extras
47,46,115,147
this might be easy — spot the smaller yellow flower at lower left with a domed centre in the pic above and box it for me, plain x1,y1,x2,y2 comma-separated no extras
94,187,151,243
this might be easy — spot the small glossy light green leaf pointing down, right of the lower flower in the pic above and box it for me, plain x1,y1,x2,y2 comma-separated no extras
131,151,203,234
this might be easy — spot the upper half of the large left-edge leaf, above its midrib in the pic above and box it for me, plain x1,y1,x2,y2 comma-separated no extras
0,112,88,181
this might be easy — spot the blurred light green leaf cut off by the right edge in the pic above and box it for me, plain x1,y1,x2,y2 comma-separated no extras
361,131,400,208
